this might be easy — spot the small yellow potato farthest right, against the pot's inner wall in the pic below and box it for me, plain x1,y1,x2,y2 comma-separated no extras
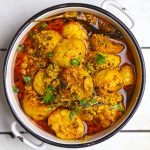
120,65,135,86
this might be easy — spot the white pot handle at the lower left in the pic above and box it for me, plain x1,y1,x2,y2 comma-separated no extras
11,121,46,150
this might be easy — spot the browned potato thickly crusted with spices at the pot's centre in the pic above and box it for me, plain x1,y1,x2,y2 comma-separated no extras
61,68,94,100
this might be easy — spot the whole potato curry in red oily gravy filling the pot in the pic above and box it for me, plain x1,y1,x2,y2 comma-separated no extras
13,12,136,140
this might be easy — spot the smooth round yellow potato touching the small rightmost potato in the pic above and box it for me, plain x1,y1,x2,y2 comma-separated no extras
93,69,123,94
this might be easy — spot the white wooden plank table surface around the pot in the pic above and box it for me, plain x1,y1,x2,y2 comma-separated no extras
0,0,150,150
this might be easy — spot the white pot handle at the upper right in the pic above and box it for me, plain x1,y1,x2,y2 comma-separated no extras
101,0,135,29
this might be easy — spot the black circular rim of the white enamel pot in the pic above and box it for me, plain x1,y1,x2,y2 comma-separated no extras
3,3,146,148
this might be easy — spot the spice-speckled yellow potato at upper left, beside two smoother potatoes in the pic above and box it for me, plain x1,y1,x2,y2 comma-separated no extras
34,30,62,53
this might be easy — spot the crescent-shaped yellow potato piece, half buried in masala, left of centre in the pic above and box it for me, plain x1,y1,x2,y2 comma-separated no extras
33,69,45,95
